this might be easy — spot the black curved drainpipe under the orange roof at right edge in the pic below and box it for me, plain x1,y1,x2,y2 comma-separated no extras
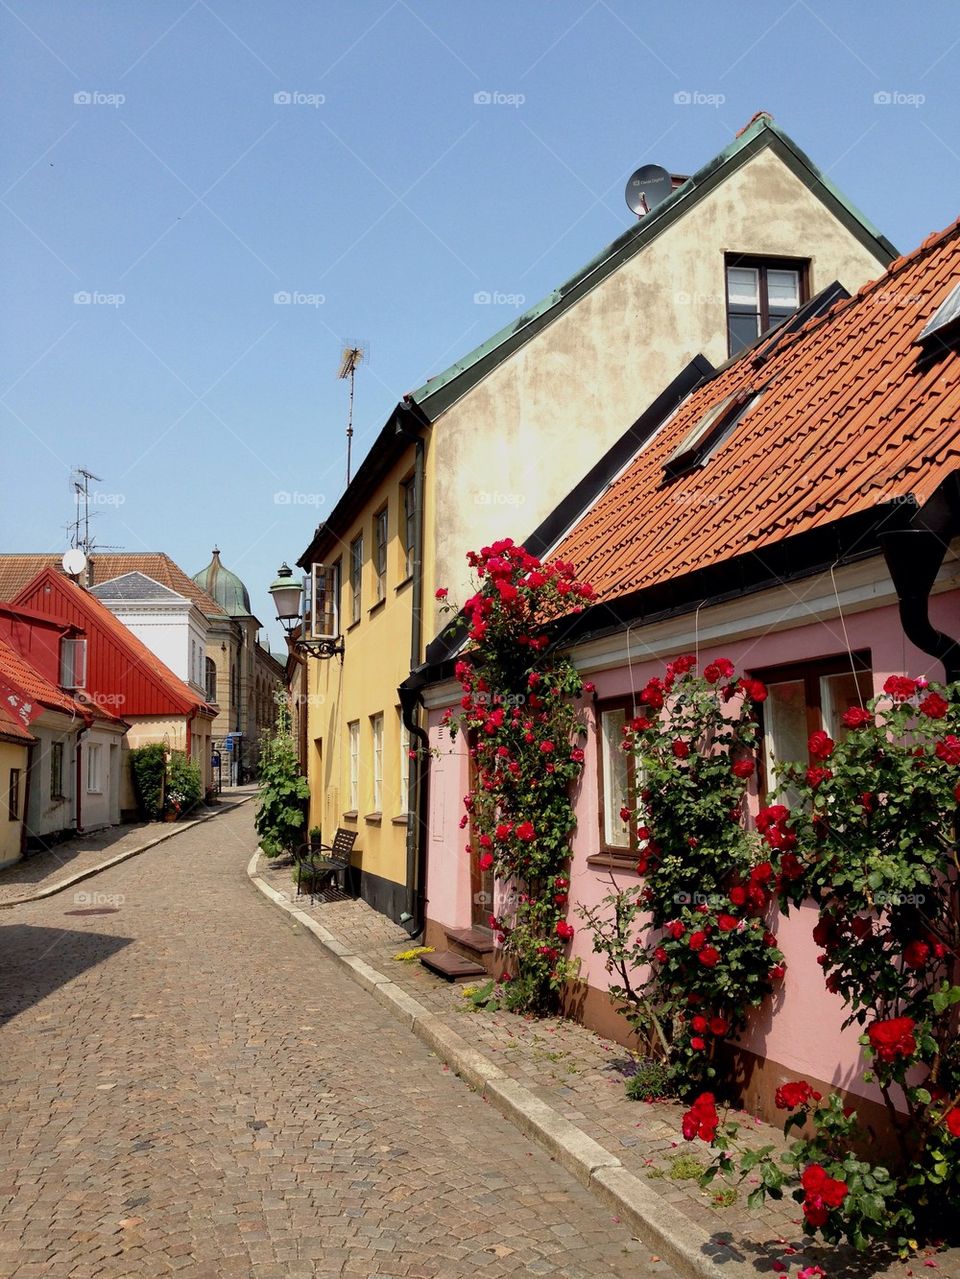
879,476,960,684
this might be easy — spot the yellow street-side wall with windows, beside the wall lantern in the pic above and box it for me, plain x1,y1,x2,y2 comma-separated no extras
306,445,416,884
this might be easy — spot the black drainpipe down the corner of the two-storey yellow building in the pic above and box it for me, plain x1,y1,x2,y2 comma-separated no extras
396,400,430,938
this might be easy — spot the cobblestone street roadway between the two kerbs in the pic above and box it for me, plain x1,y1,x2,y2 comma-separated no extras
0,804,672,1279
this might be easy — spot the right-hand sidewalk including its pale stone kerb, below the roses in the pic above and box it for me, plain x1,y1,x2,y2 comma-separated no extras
249,857,960,1279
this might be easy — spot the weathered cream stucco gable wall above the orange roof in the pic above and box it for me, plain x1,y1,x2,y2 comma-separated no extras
433,148,885,601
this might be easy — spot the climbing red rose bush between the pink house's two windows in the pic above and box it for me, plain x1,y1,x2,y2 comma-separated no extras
582,656,793,1095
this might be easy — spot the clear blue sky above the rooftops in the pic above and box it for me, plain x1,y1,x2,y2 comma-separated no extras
0,0,960,638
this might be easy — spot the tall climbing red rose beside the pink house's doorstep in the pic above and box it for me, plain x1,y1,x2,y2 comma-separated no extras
437,538,593,1013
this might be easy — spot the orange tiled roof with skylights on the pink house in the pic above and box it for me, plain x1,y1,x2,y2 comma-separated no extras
555,221,960,600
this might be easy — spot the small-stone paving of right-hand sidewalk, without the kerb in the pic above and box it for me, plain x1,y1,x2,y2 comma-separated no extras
258,857,960,1279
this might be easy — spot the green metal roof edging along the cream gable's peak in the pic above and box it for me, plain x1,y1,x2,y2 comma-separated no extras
406,113,897,421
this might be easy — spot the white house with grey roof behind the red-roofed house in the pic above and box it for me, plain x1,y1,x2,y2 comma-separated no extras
89,573,208,694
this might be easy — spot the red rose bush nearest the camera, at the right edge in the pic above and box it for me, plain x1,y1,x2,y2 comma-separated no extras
685,675,960,1247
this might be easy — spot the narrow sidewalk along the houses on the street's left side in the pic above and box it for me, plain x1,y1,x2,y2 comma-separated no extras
0,785,257,911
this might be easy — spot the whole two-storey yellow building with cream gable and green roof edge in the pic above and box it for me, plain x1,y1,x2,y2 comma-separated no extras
288,114,895,932
